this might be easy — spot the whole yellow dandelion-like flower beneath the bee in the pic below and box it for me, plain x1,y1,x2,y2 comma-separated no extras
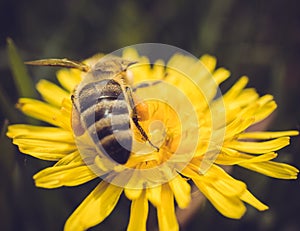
7,49,298,231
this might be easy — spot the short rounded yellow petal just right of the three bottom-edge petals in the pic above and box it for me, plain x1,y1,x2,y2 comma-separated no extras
169,176,191,209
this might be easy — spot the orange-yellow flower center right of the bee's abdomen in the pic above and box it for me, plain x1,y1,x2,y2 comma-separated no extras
126,100,182,168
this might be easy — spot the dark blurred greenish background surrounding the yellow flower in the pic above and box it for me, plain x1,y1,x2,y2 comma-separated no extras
0,0,300,231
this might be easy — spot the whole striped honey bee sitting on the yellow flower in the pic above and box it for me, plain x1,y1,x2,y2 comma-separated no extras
25,56,159,164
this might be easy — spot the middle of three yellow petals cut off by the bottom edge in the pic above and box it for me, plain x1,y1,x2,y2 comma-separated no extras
127,190,148,231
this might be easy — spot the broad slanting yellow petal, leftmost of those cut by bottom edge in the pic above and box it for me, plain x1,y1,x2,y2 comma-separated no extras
64,181,123,231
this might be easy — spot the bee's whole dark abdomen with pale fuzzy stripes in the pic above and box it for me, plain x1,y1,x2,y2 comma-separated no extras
77,79,132,164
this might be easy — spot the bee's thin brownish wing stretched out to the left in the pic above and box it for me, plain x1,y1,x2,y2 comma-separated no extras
25,59,91,72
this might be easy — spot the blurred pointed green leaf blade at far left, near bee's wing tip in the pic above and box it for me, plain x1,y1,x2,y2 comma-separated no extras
7,38,36,98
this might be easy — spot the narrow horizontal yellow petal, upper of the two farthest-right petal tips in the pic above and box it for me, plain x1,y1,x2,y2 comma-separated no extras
239,131,299,140
